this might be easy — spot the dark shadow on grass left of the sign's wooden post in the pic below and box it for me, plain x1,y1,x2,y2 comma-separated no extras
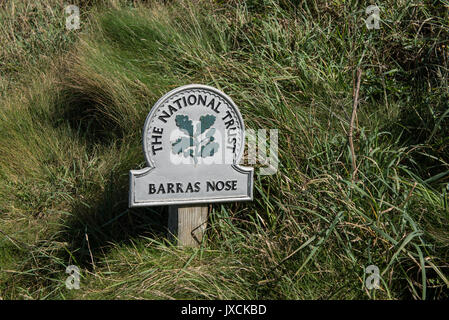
61,169,168,269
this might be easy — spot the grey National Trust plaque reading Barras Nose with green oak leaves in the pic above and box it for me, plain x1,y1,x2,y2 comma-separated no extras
129,84,253,207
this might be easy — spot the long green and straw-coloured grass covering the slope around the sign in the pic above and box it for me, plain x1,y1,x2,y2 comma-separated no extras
0,0,449,299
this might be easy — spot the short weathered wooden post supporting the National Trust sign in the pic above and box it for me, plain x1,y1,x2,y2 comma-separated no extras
168,204,209,247
